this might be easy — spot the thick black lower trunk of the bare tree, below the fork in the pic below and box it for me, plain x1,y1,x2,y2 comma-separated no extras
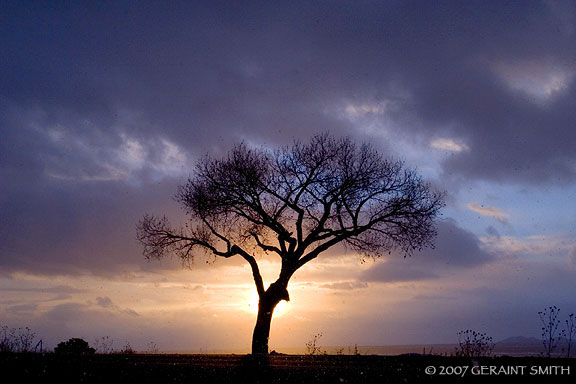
252,284,290,355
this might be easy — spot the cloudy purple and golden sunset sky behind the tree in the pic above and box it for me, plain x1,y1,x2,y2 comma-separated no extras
0,0,576,352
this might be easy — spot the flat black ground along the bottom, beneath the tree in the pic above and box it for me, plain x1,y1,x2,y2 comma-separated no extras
0,354,576,384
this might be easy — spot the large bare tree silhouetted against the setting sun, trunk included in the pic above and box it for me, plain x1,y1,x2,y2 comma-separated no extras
138,134,444,354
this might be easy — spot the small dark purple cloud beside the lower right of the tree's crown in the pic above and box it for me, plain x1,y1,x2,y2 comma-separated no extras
360,220,494,282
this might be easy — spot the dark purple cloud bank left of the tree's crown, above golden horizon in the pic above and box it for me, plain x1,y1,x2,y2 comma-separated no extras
0,172,182,275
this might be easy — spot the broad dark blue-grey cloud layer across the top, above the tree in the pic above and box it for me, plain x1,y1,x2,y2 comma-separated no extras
2,2,576,176
